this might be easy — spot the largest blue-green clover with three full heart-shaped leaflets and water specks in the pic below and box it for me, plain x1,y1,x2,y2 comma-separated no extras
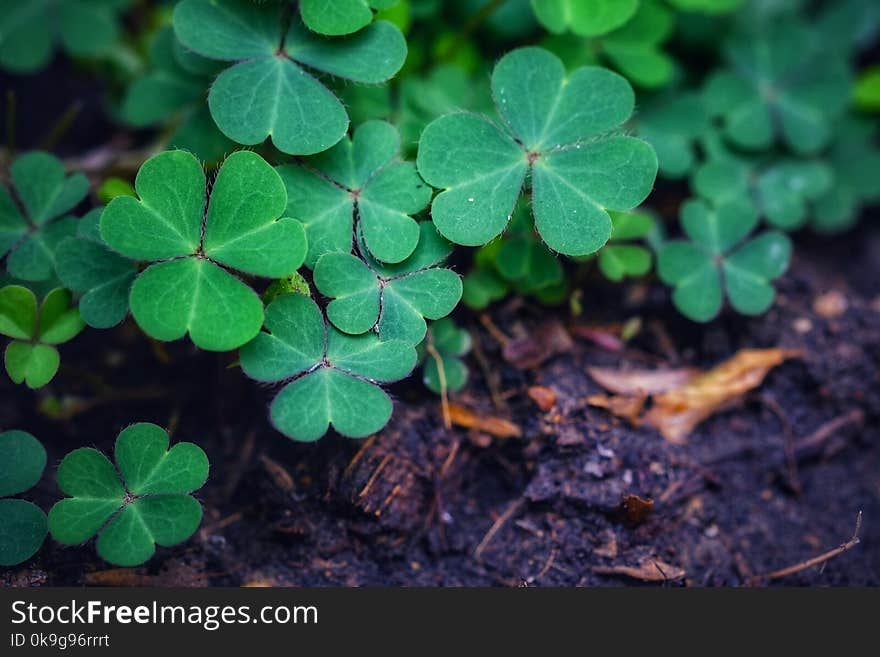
417,48,657,255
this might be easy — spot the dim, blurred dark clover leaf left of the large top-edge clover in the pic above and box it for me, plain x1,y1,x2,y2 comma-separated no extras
120,27,232,162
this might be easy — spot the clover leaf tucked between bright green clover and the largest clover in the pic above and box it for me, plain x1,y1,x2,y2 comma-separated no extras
278,121,431,267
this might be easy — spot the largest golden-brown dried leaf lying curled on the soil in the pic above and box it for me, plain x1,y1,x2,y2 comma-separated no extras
644,349,800,443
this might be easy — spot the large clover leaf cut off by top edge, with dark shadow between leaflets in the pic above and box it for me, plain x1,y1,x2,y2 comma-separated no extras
174,0,406,155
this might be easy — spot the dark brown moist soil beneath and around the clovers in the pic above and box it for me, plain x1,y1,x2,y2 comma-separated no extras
0,59,880,586
